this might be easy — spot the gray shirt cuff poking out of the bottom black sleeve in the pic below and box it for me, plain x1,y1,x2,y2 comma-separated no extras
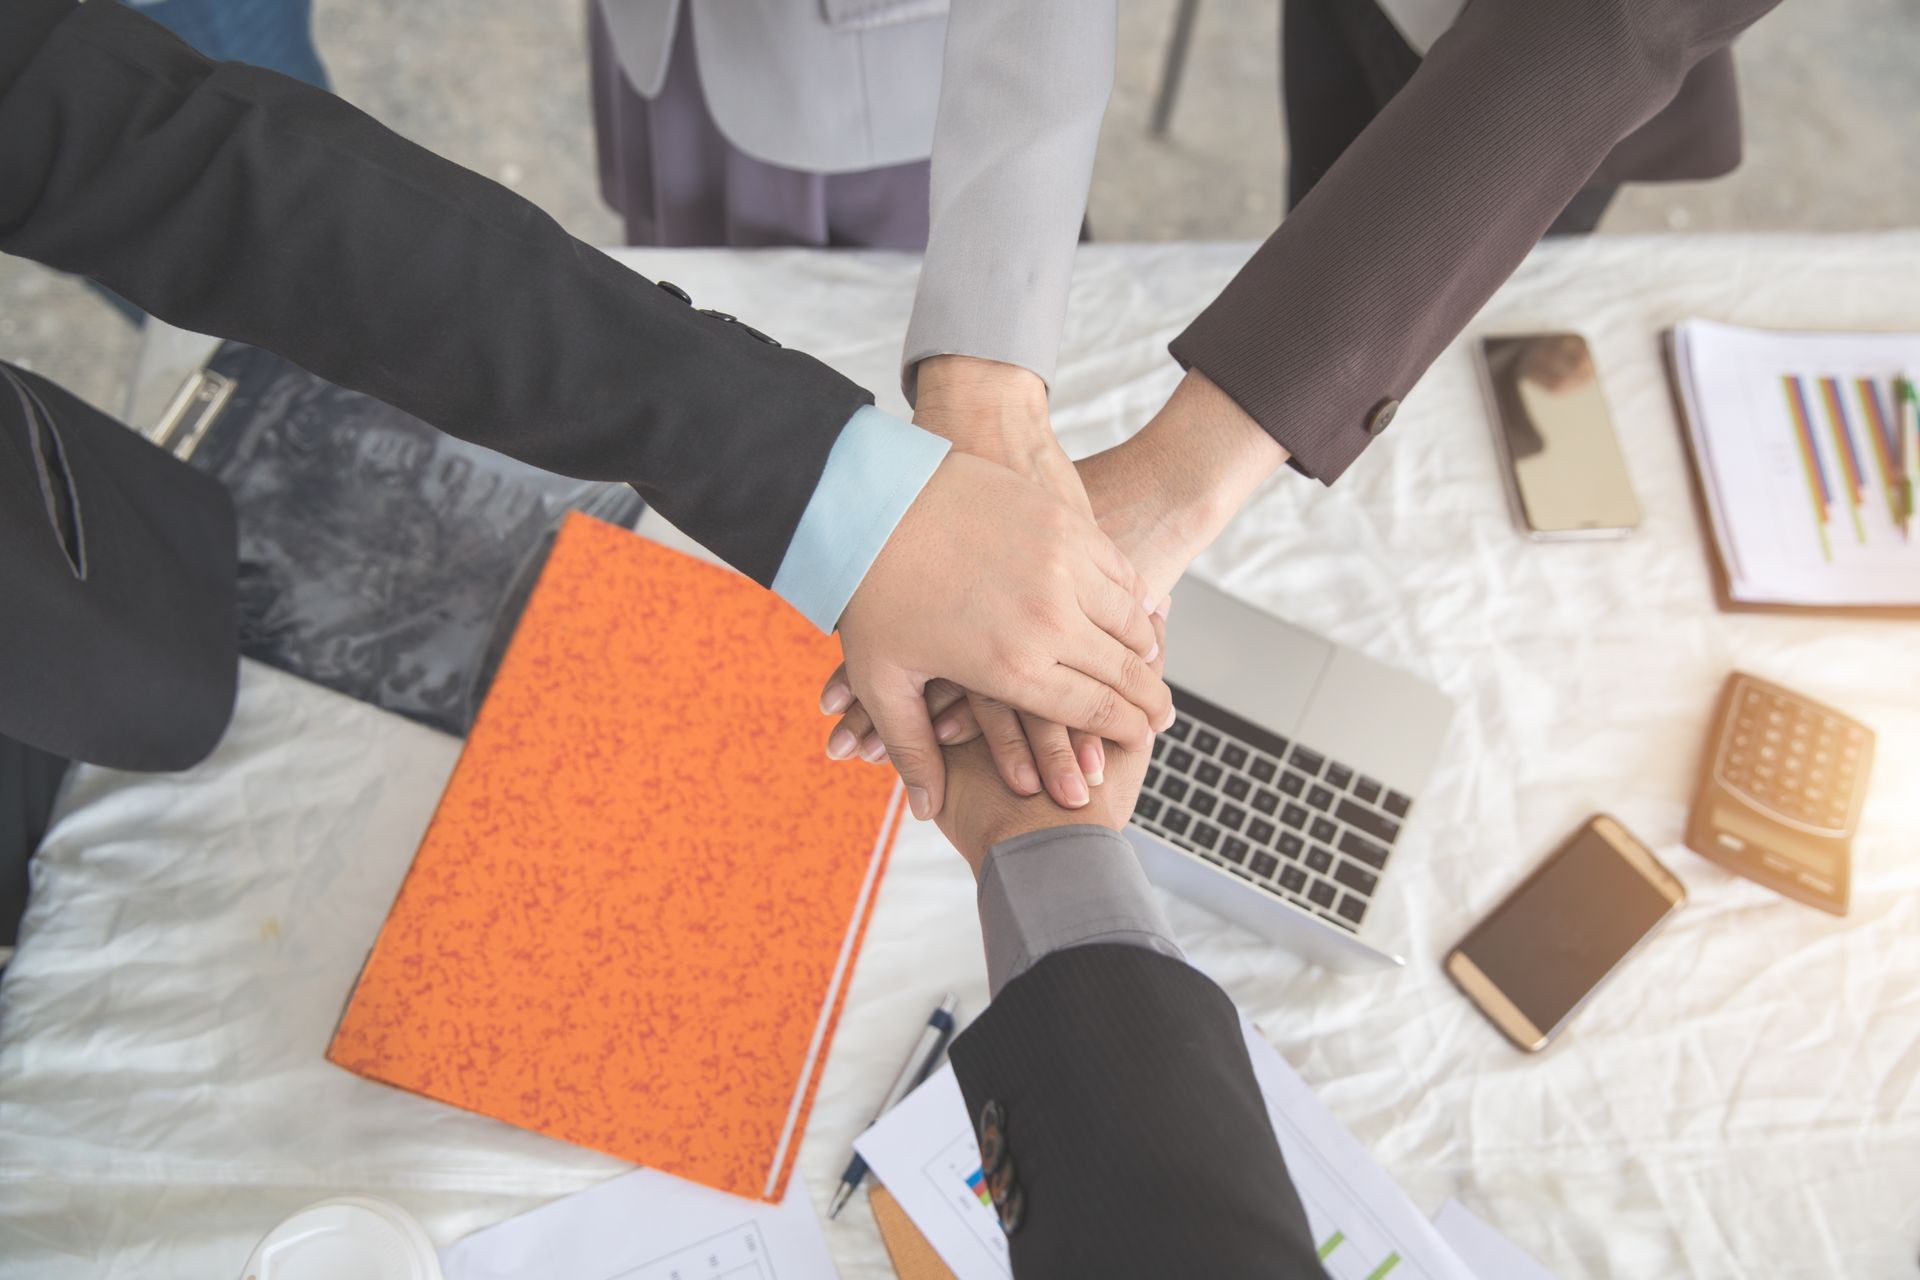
979,823,1183,996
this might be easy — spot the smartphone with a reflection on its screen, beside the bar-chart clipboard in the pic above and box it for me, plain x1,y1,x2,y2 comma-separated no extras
1480,334,1640,537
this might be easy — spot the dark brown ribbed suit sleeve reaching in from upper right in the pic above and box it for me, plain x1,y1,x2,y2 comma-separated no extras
1173,0,1774,484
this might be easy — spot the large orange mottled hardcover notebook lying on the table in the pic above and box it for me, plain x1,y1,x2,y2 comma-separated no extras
326,516,902,1201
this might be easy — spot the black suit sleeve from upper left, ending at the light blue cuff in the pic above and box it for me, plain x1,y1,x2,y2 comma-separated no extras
0,0,872,583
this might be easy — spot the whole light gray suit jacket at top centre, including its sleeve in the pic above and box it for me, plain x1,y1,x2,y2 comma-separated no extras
597,0,1116,399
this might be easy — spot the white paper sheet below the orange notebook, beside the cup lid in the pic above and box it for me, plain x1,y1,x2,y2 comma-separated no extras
440,1169,839,1280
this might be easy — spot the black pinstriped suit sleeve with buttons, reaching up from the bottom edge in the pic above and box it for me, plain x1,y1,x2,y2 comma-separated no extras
952,946,1325,1280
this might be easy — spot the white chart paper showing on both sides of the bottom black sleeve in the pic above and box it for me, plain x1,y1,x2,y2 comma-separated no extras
854,1023,1484,1280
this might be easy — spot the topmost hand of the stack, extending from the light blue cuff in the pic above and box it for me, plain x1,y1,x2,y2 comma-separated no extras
824,451,1173,818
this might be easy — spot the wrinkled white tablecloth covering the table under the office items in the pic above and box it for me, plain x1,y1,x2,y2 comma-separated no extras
0,234,1920,1280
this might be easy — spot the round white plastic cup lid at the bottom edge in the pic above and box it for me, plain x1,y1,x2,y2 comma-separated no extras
240,1196,442,1280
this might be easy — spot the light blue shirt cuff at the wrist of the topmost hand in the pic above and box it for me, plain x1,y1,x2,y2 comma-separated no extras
774,405,952,633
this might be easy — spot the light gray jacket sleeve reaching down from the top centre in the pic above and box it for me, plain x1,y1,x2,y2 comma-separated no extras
900,0,1117,401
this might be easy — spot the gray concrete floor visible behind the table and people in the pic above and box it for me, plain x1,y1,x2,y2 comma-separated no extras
0,0,1920,420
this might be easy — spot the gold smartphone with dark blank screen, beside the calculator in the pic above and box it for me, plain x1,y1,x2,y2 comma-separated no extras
1446,814,1686,1054
